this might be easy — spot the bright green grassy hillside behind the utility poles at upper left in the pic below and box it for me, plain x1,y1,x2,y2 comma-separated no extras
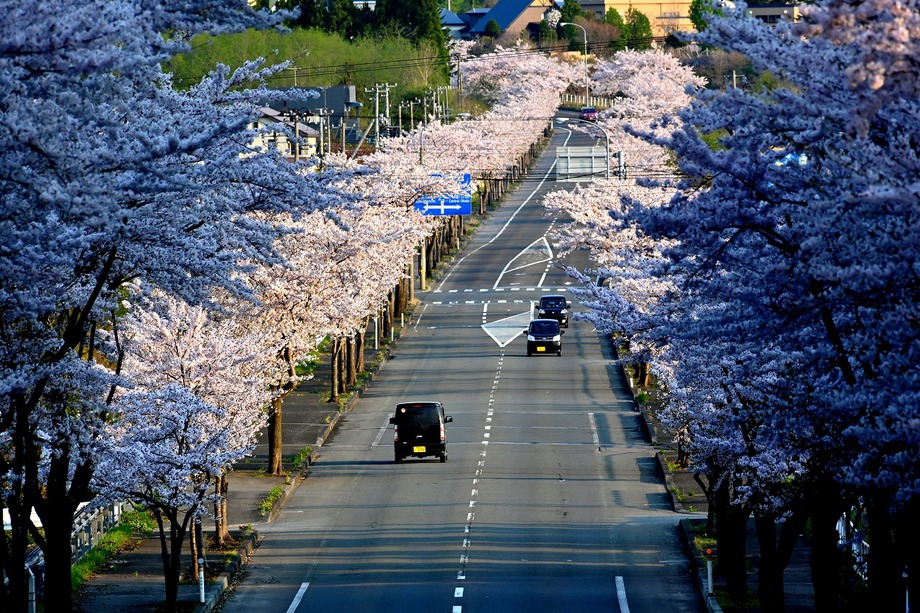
166,30,446,96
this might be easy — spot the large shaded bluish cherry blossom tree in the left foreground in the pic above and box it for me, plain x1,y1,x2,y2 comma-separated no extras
0,0,356,610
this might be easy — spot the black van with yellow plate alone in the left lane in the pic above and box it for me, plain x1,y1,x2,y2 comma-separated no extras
390,401,454,464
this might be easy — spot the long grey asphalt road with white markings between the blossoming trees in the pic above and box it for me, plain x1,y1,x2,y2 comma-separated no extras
217,112,704,613
